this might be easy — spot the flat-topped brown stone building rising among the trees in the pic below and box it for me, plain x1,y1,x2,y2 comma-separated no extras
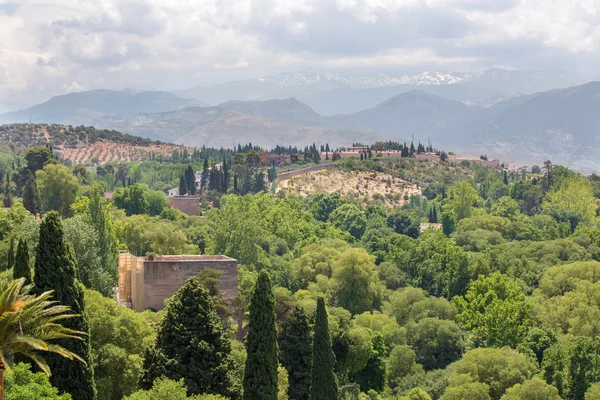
118,253,238,312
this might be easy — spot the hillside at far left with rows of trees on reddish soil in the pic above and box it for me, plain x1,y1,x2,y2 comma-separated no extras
0,124,181,164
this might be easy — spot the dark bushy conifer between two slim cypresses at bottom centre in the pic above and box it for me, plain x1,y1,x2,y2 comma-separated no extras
279,307,312,400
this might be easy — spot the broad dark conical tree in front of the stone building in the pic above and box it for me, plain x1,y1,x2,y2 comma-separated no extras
140,278,241,400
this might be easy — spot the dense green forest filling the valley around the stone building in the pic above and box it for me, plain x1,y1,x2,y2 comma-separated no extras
0,144,600,400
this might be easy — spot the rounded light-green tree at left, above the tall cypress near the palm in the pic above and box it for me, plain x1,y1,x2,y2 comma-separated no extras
36,164,79,217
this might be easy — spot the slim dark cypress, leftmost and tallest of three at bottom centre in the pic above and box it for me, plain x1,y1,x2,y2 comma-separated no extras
244,271,278,400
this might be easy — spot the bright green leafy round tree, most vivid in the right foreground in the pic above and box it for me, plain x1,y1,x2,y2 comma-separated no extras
453,273,531,348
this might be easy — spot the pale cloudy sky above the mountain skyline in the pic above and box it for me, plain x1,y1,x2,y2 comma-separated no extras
0,0,600,102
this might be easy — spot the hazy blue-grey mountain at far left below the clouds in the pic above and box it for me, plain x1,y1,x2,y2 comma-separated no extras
0,90,209,125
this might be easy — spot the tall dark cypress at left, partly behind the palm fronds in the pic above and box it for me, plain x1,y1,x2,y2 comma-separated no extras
34,211,96,400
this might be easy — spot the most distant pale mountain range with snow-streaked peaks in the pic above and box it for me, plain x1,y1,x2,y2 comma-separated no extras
174,69,589,115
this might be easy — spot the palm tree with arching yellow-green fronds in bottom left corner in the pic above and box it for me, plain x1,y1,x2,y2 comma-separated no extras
0,278,85,400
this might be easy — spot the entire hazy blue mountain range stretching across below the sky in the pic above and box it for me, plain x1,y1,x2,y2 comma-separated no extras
0,69,600,171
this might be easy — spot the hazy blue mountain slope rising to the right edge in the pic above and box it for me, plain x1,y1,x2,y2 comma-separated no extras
460,82,600,172
